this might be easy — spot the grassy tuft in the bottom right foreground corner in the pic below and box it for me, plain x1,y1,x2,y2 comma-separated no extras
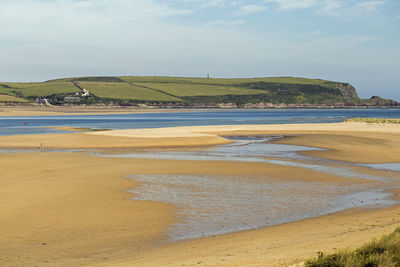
305,228,400,267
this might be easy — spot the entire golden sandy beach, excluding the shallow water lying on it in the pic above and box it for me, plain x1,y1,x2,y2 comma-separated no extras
0,123,400,266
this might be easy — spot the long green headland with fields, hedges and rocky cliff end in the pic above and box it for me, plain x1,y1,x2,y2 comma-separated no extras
0,76,397,107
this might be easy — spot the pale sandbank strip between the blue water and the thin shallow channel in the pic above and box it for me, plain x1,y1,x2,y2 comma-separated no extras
0,122,400,164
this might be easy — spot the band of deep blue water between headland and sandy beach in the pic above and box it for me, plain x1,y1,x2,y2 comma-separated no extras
0,109,400,135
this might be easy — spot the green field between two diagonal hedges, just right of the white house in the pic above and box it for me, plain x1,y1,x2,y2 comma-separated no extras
79,82,182,101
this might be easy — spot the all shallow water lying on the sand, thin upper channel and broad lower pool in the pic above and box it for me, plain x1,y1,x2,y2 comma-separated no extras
100,136,400,240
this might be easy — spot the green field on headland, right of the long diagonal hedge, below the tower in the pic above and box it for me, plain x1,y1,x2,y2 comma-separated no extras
136,83,265,96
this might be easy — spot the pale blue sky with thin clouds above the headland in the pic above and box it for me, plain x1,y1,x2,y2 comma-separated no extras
0,0,400,101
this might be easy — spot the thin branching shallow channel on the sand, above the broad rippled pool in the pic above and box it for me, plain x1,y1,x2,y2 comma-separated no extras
102,136,385,180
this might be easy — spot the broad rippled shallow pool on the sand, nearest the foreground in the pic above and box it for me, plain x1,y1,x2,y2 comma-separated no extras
129,175,395,240
